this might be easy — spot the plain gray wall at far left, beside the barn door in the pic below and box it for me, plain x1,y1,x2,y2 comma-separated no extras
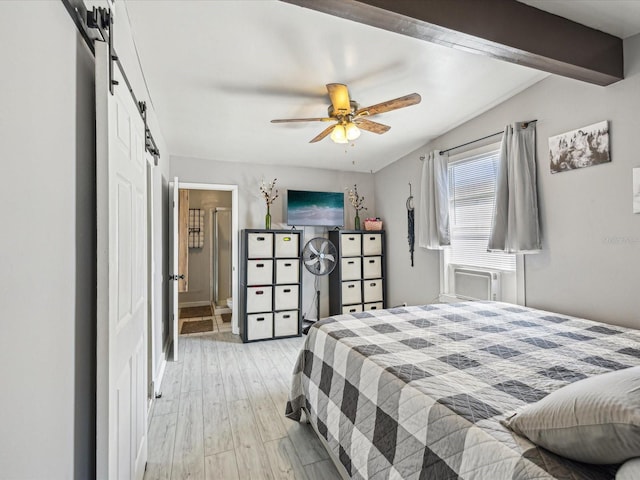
0,2,96,479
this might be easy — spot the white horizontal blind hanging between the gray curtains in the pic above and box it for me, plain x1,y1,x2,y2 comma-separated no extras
446,150,516,271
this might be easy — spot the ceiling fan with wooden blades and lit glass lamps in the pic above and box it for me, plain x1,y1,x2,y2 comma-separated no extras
271,83,422,143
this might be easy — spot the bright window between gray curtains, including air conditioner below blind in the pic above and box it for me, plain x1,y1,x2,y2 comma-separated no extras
441,144,522,303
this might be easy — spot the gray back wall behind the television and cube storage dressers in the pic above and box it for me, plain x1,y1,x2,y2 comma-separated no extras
171,156,376,318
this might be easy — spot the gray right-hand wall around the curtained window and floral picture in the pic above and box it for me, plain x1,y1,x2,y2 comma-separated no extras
375,32,640,328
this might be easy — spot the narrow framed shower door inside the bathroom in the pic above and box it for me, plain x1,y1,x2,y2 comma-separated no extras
212,207,232,307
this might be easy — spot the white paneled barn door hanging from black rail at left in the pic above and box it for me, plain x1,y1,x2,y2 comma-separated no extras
95,42,147,480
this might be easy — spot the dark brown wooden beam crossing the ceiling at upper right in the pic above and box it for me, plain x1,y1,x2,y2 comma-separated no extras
282,0,624,85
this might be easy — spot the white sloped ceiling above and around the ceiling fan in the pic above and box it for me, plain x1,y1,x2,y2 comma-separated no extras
126,0,640,172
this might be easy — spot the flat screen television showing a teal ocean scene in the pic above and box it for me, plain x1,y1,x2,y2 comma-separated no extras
287,190,344,227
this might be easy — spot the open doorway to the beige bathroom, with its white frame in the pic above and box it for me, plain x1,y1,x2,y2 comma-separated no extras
170,179,238,358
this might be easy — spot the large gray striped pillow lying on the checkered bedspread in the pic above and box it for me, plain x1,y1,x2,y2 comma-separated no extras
502,367,640,464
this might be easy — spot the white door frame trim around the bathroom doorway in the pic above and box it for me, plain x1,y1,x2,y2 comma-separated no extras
174,179,240,335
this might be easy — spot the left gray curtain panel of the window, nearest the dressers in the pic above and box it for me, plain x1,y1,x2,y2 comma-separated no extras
418,150,451,250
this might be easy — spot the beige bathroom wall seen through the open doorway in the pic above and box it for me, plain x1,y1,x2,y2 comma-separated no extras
178,190,231,305
